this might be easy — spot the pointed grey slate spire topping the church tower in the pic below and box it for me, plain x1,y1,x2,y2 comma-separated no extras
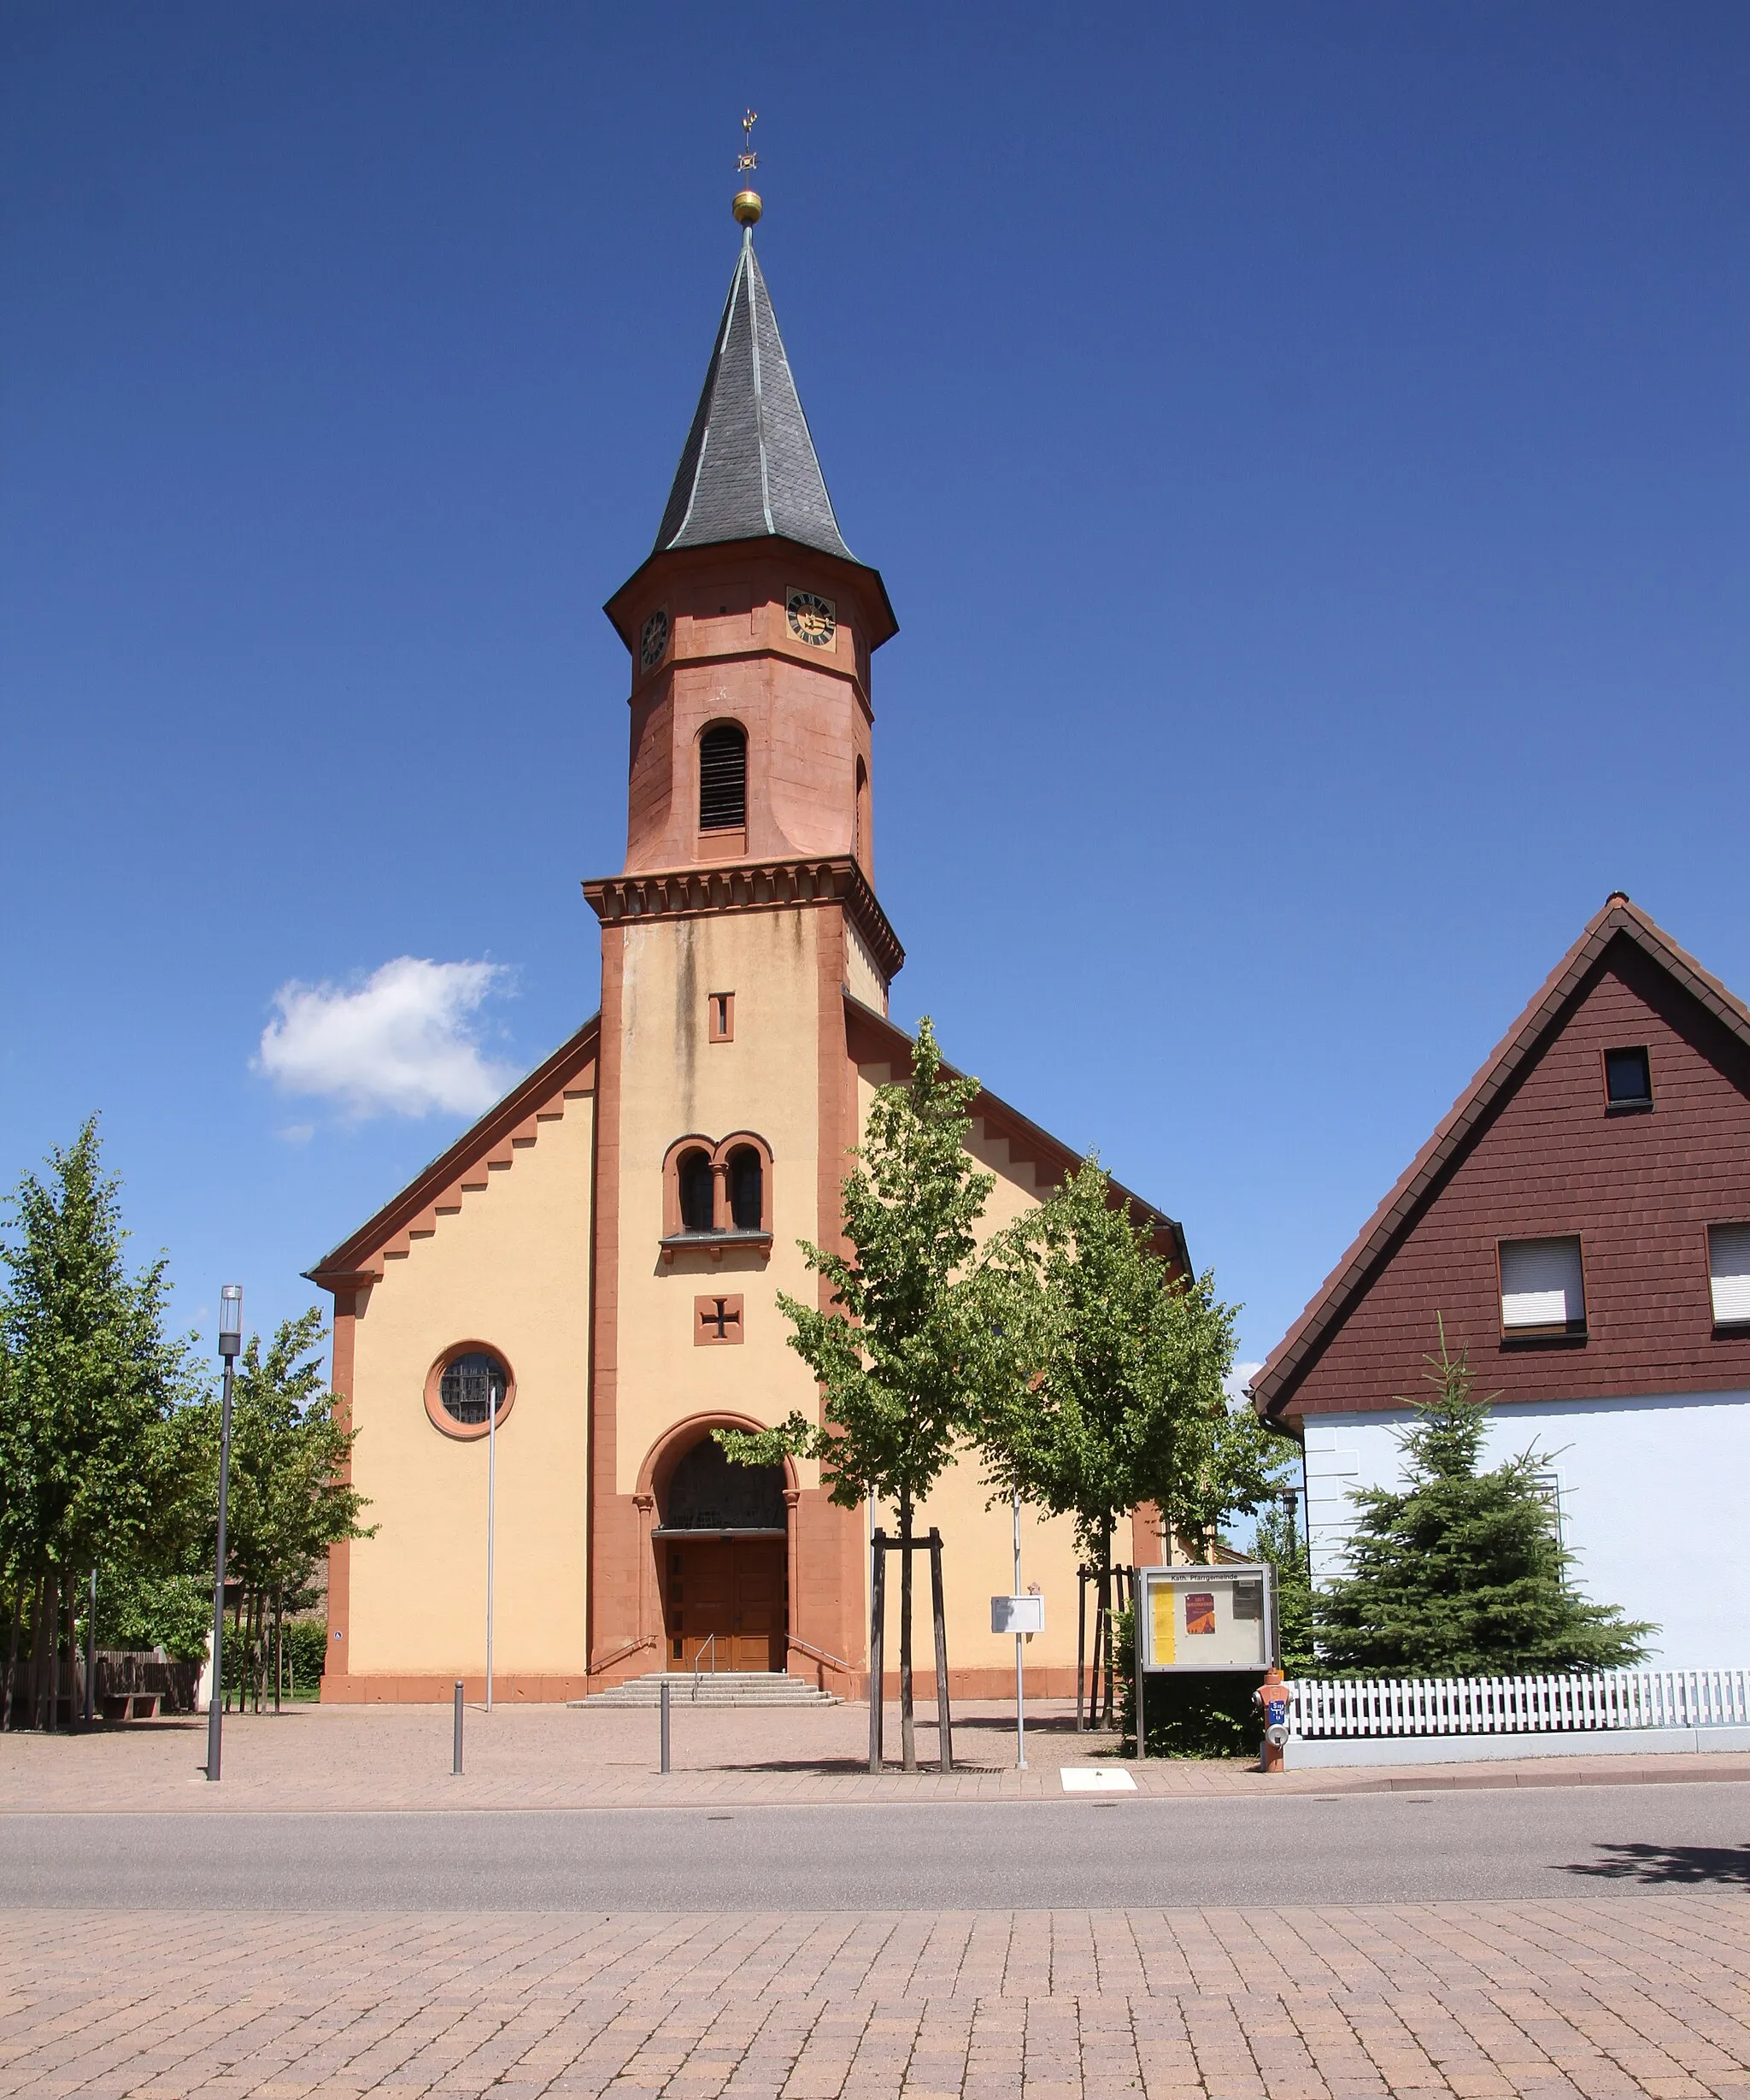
653,226,856,561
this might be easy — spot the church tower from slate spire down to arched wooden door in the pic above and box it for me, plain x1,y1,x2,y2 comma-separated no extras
585,199,902,1676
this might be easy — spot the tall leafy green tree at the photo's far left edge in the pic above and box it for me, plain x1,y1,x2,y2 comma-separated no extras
0,1120,199,1726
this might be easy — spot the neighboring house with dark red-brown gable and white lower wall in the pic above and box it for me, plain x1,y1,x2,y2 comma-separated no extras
1251,895,1750,1669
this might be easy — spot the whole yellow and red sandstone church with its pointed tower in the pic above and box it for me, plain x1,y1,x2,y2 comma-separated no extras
310,193,1189,1701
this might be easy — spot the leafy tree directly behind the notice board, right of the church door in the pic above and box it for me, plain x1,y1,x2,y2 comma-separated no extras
980,1157,1286,1720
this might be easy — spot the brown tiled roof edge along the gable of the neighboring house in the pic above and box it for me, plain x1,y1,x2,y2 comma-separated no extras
1251,891,1750,1417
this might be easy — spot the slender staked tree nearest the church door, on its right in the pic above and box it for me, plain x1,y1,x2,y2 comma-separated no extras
718,1019,1026,1770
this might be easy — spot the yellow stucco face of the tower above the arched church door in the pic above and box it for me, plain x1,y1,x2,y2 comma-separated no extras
617,909,820,1493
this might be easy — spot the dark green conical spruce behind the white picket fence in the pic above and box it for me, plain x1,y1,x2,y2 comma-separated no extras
1313,1321,1658,1678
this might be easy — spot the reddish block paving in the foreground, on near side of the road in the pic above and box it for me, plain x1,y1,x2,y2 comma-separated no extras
0,1894,1750,2100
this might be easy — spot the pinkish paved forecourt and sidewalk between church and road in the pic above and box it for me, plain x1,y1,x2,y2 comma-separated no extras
0,1701,1750,1812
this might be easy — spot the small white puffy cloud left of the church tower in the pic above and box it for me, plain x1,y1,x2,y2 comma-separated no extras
254,956,514,1117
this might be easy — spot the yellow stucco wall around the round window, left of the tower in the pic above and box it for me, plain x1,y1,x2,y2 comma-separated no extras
349,1097,596,1678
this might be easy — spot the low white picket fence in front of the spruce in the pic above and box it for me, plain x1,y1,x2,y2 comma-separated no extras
1286,1669,1750,1741
